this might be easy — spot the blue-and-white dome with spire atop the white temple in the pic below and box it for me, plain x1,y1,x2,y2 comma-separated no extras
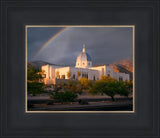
75,44,92,68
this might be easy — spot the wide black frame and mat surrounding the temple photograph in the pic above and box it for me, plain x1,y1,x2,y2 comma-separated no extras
0,0,160,138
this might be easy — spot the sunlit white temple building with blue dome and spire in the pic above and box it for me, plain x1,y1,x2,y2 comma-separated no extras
42,45,130,84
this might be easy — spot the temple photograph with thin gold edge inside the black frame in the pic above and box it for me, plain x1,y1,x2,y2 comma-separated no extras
25,25,135,113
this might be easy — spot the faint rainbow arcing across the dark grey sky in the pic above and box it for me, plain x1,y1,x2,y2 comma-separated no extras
33,27,69,58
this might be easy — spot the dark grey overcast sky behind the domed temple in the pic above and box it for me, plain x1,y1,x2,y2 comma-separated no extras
27,27,133,65
